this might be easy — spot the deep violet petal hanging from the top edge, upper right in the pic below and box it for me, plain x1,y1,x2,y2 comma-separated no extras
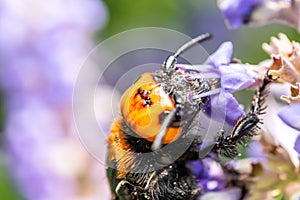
218,0,262,28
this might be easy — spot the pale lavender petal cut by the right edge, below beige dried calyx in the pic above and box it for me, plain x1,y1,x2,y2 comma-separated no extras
278,103,300,131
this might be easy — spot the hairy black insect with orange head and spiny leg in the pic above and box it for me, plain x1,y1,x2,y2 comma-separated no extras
107,34,269,200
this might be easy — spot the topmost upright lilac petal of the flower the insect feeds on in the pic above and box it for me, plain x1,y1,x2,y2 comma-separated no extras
205,42,233,69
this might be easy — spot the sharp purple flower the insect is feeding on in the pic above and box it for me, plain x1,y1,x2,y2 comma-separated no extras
176,42,257,126
